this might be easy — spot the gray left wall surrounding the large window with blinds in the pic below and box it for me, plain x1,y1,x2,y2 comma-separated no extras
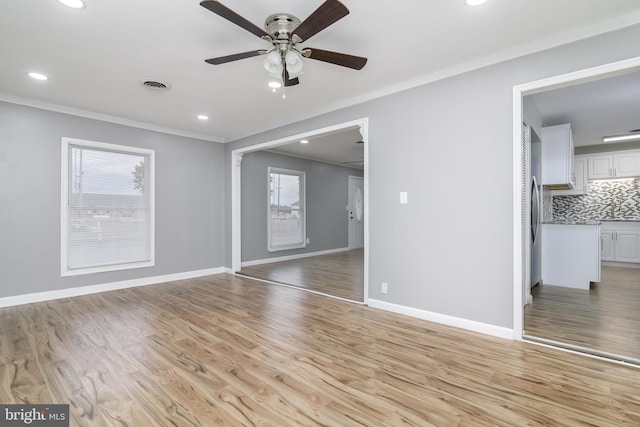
0,102,225,297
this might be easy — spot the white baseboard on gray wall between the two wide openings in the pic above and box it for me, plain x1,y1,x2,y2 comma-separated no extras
367,299,514,340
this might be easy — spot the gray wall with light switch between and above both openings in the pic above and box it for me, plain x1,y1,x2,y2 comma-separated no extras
225,26,640,328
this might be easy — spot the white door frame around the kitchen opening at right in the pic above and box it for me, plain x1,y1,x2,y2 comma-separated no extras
512,56,640,341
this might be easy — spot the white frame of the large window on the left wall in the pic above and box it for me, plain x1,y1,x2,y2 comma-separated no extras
60,137,155,277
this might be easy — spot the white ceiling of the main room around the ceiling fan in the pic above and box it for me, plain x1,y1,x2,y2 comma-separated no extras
0,0,640,142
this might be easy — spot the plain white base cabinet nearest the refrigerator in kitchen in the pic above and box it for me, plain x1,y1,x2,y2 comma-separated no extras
541,224,601,289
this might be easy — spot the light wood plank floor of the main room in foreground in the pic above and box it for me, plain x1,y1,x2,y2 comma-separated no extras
0,274,640,427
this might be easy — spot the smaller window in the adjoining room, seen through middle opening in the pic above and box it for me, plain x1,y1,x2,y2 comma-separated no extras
268,168,306,252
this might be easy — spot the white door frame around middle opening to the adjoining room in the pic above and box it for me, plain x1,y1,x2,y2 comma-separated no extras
231,117,369,304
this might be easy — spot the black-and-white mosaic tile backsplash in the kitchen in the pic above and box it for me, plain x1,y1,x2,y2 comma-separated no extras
543,178,640,221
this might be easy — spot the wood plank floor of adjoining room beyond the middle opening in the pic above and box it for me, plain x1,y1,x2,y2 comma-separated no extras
240,249,364,302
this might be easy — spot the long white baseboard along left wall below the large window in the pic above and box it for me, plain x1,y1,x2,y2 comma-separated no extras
0,267,226,308
